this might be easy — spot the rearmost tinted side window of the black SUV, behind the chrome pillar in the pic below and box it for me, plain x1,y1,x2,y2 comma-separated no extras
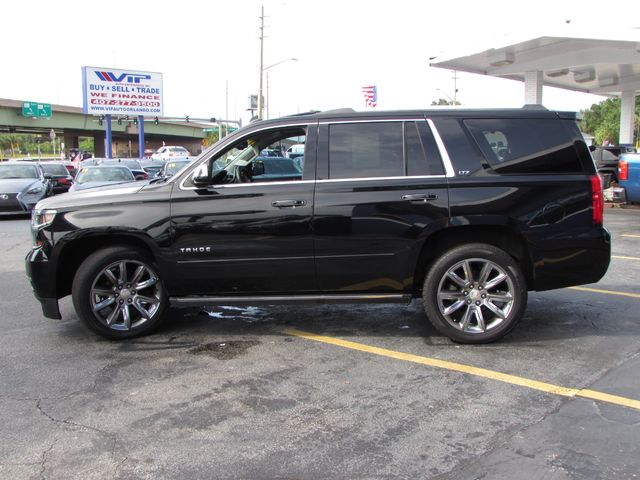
464,118,583,174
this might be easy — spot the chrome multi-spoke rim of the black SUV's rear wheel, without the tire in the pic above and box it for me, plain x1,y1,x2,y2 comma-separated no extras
437,258,514,334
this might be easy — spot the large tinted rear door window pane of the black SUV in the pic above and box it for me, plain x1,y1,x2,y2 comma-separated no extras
329,122,404,178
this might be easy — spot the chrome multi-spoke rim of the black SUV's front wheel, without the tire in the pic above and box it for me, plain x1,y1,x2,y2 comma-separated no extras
90,260,162,331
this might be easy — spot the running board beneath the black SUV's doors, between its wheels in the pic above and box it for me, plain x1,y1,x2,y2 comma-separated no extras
169,293,411,307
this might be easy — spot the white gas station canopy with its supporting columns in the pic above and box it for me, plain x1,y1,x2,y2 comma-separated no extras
431,30,640,143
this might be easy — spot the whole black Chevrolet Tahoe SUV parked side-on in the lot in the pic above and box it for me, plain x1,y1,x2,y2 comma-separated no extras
26,108,610,343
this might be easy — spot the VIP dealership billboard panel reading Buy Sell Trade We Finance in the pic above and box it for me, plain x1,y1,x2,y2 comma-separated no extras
82,67,162,117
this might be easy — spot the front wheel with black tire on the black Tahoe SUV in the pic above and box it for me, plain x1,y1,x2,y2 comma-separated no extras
72,246,168,340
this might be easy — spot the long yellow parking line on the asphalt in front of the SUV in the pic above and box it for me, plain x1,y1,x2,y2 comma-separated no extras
284,328,640,410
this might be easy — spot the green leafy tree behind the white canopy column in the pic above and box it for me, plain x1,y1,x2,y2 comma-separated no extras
581,97,640,145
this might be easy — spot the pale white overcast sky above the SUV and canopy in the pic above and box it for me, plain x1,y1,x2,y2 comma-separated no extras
0,0,640,124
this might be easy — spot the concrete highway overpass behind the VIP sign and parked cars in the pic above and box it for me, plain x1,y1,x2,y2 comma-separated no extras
0,98,211,157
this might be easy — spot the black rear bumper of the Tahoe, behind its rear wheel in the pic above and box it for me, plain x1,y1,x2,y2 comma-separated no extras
532,227,611,291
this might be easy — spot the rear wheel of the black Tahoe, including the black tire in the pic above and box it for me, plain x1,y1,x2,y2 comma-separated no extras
422,243,527,343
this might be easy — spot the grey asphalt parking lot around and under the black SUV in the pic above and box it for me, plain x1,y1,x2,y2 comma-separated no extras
0,208,640,479
